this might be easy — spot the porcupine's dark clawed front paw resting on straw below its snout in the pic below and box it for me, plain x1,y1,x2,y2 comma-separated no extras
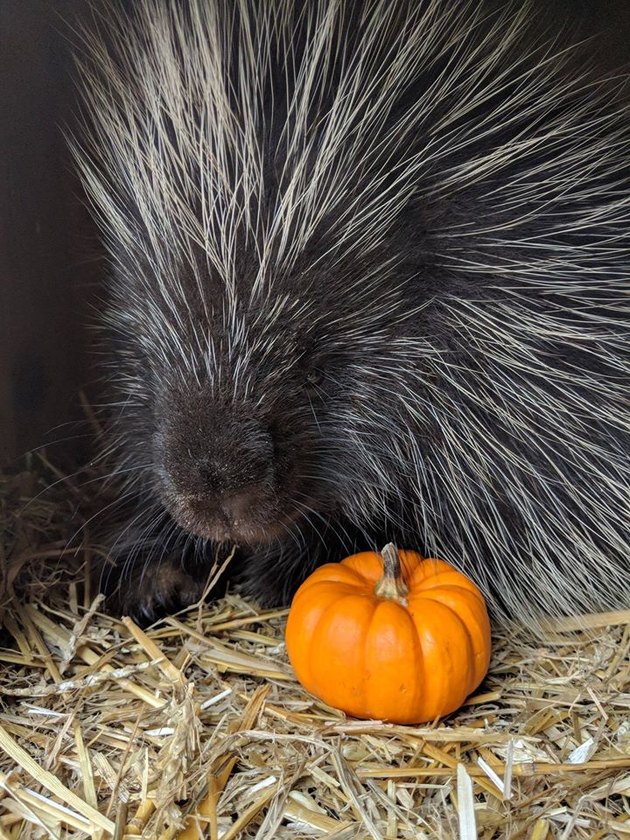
105,560,204,627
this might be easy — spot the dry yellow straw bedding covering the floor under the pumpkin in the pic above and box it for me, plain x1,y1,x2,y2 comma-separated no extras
0,460,630,840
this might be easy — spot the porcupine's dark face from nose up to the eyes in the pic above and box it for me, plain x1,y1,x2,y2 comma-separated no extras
151,276,339,544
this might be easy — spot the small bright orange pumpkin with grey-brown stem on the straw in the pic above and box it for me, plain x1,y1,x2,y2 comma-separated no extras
286,544,490,723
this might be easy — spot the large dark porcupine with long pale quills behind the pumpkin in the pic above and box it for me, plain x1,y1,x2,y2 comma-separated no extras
75,0,630,622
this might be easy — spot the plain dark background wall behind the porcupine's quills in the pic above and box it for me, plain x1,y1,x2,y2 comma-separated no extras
0,0,630,463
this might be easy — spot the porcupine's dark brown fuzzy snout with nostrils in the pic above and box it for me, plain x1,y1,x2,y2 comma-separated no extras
157,398,278,543
